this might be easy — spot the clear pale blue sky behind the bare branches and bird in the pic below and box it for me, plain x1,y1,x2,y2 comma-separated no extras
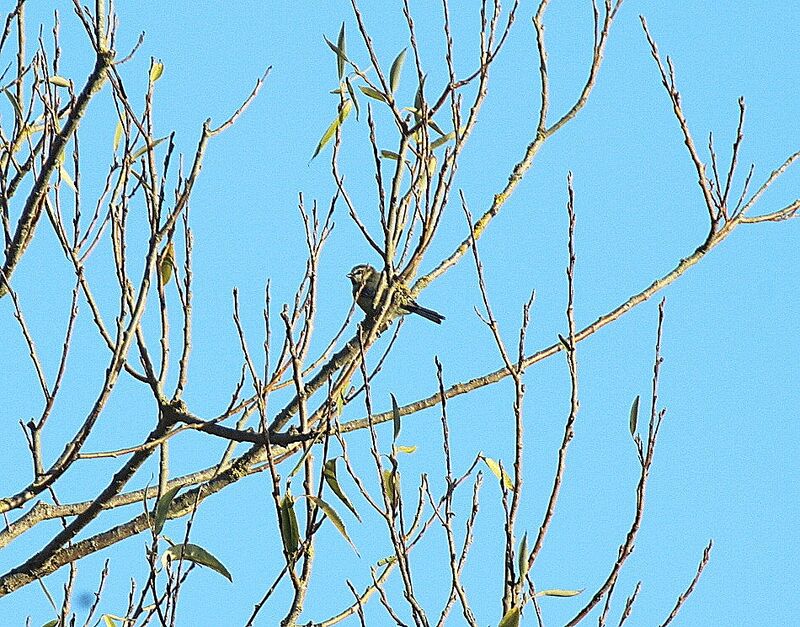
0,0,800,626
